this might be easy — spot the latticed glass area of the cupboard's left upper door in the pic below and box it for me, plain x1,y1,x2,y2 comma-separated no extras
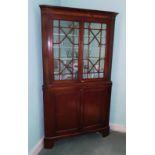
53,20,79,80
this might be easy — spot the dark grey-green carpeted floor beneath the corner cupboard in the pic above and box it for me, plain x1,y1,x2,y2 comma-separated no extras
39,132,126,155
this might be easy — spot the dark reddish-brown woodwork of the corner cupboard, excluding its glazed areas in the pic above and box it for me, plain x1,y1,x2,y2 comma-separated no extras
40,5,117,148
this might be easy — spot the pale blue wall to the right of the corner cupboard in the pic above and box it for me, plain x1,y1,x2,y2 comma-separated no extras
61,0,126,126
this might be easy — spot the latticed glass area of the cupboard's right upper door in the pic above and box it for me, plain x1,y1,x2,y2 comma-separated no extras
83,23,106,79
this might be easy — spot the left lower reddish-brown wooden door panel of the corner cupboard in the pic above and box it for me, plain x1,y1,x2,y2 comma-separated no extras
54,89,80,133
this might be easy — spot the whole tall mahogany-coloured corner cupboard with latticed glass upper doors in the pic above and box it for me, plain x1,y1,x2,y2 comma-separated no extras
40,5,117,148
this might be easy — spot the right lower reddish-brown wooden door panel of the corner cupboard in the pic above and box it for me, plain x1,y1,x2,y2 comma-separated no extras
82,88,111,129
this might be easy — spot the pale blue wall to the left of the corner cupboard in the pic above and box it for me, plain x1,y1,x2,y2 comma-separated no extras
28,0,59,152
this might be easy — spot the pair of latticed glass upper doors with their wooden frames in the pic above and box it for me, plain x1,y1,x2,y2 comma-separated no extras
48,19,110,83
